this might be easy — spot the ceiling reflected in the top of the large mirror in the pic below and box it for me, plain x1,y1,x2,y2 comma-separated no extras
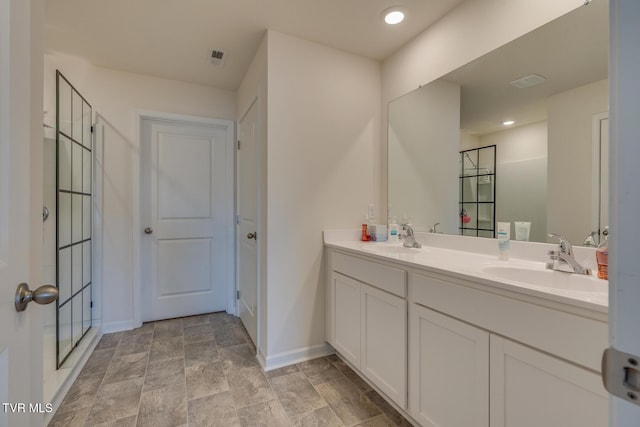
443,0,609,135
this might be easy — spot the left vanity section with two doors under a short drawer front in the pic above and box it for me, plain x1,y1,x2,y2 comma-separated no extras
327,252,407,408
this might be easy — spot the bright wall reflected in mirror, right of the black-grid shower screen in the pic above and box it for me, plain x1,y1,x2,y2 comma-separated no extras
480,122,547,242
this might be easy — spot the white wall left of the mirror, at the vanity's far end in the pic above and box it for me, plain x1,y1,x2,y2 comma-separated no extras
263,31,380,365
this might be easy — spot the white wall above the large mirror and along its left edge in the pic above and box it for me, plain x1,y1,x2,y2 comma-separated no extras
380,0,584,221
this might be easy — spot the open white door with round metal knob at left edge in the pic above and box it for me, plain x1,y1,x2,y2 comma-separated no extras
0,0,45,426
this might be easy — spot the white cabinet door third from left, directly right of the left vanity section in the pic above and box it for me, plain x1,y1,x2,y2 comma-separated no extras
409,304,489,427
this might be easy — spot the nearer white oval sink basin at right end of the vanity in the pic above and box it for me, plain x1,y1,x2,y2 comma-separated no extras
482,264,609,294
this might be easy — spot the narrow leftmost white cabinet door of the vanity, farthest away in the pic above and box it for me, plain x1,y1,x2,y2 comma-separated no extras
331,272,362,368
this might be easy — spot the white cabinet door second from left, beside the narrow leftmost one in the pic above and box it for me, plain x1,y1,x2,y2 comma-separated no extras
360,285,407,408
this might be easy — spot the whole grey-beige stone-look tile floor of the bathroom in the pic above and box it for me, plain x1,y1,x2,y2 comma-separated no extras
49,313,410,427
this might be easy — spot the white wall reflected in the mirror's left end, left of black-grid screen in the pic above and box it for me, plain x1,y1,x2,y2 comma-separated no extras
388,80,460,234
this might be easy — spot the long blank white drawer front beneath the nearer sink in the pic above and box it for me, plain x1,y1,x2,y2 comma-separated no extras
410,273,608,372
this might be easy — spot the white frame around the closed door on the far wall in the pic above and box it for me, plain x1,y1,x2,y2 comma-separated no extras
131,110,237,328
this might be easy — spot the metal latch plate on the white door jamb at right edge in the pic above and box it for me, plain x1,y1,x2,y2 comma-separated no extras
602,347,640,406
